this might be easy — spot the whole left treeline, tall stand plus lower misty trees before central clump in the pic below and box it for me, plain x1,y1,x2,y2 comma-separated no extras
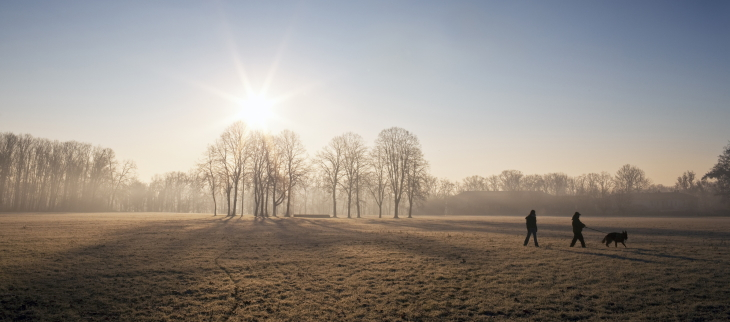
0,133,211,212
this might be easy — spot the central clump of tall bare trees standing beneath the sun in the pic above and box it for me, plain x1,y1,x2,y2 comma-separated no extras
197,121,428,218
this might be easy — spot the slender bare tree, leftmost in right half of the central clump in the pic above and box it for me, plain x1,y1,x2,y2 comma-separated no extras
315,136,345,218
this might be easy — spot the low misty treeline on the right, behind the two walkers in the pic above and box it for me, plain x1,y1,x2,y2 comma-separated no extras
422,164,727,215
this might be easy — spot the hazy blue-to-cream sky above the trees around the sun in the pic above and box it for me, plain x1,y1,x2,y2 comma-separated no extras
0,1,730,185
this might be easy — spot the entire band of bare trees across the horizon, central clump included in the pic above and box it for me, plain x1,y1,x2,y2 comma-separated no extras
0,129,730,217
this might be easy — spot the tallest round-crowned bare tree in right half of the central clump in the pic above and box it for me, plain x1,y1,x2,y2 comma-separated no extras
375,127,421,218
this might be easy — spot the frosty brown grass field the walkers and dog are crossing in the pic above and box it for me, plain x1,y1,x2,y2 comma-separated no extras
0,213,730,321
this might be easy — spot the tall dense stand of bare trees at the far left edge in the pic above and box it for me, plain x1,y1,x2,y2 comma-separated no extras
0,133,136,211
